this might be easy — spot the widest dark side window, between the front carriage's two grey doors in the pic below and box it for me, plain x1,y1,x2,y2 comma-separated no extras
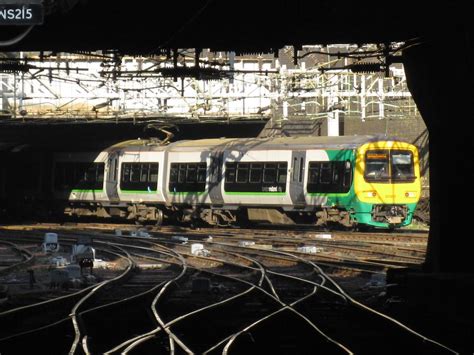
224,162,288,192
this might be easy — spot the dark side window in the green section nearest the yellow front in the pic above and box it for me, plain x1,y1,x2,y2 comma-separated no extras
306,161,352,193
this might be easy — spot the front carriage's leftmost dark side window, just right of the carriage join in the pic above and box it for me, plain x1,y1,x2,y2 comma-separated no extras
168,163,207,192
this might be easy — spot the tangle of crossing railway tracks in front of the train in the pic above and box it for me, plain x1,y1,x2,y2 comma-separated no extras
0,225,462,354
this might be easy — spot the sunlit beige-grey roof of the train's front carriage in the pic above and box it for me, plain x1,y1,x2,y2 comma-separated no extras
163,135,400,151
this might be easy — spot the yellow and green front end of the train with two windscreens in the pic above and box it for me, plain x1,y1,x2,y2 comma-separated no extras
352,140,421,229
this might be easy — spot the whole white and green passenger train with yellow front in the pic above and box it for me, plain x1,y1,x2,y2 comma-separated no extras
45,136,421,229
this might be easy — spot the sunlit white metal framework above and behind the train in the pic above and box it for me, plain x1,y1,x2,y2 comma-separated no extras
0,45,418,126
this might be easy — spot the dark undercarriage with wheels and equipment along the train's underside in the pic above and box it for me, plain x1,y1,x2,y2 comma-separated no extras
0,197,408,230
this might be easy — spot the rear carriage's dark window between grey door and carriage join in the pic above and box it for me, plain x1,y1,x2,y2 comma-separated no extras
120,163,158,191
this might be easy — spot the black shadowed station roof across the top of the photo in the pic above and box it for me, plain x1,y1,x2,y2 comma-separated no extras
0,0,460,55
